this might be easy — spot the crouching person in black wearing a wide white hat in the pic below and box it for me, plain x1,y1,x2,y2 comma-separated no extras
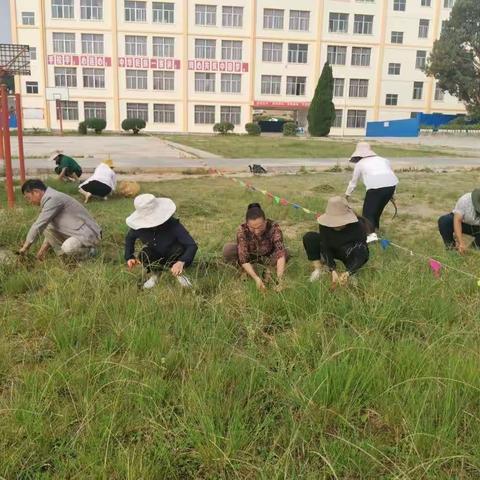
125,193,198,289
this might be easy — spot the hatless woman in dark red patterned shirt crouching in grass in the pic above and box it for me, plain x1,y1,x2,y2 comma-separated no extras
223,203,288,290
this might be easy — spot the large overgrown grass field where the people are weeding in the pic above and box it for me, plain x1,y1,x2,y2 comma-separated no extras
0,172,480,480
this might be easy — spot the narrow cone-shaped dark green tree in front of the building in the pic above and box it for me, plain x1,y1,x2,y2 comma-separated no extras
307,62,335,137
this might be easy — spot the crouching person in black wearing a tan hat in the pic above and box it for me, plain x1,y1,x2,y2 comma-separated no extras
303,197,369,286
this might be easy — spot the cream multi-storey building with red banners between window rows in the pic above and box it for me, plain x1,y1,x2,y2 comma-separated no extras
10,0,464,135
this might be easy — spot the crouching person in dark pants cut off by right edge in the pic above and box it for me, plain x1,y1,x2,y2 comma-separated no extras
438,188,480,255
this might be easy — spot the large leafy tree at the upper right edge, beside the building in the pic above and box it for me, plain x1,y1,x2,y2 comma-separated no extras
425,0,480,117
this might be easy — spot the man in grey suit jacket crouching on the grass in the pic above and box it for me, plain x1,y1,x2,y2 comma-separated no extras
19,180,102,260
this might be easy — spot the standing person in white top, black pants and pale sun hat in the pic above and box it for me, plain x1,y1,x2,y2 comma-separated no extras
345,142,398,243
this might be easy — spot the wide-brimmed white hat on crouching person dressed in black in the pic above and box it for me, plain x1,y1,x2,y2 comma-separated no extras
126,193,177,230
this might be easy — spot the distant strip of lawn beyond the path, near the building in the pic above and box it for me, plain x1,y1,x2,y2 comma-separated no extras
162,135,458,158
